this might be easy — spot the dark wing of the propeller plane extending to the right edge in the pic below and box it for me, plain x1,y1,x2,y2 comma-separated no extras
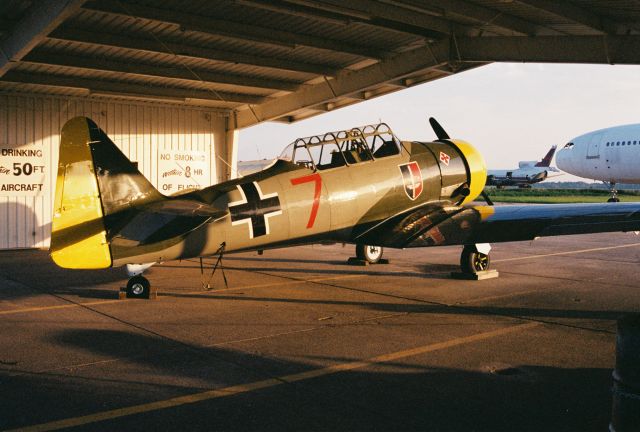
356,203,640,248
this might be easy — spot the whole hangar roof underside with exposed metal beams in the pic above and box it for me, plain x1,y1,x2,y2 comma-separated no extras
0,0,640,127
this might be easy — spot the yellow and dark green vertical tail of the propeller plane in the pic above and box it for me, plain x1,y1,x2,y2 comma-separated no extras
49,117,162,269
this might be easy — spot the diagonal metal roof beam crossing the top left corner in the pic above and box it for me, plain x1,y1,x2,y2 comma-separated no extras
0,0,85,77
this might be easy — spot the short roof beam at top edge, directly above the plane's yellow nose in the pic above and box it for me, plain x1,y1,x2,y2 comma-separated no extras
403,0,540,36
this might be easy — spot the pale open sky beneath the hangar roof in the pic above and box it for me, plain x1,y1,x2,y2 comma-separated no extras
238,63,640,181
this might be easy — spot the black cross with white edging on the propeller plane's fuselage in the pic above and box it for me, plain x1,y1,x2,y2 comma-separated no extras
229,182,282,238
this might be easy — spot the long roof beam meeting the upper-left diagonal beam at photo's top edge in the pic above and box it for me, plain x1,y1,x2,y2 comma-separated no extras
84,2,390,60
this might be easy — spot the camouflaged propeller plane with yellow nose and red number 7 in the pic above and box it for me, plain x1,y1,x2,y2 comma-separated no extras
50,117,640,297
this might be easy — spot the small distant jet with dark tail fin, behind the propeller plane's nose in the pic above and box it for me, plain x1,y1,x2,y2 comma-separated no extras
487,146,561,188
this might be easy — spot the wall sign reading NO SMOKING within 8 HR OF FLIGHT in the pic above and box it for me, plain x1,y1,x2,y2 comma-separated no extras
158,150,211,195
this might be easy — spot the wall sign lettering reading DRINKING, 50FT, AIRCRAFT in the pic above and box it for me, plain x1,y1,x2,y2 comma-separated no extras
0,146,49,197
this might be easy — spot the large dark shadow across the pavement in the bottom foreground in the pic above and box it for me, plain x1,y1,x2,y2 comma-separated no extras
0,329,611,431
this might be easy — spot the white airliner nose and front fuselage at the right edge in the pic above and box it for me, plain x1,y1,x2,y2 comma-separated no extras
556,124,640,202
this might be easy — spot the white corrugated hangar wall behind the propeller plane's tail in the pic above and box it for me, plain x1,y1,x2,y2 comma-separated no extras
0,93,230,249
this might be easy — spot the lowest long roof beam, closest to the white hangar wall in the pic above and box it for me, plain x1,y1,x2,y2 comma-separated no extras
2,71,265,104
